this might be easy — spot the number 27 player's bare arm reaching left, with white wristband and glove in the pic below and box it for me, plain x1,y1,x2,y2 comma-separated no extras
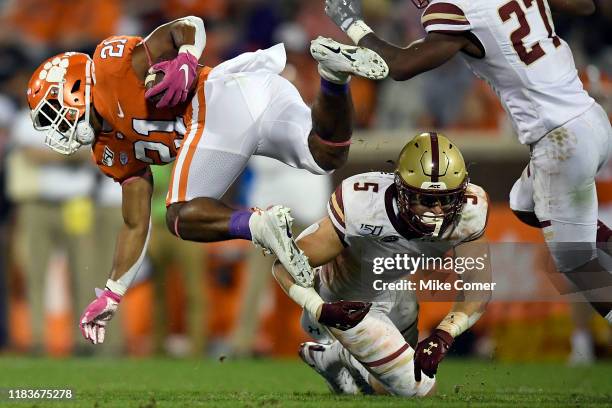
325,0,468,81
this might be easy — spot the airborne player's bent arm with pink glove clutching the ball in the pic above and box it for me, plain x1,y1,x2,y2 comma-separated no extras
135,16,206,108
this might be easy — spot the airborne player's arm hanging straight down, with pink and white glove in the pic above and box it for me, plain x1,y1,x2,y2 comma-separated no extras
79,169,153,344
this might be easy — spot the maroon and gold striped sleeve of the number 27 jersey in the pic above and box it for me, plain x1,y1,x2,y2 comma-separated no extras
421,2,472,34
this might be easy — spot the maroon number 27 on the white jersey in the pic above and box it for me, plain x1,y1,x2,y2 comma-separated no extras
498,0,561,65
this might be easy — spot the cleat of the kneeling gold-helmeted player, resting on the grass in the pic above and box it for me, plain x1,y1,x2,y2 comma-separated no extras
298,341,359,395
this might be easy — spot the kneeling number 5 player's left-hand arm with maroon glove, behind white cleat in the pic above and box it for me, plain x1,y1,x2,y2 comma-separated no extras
272,217,372,330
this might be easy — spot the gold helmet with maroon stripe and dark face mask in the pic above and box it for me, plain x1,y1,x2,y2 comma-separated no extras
395,132,469,237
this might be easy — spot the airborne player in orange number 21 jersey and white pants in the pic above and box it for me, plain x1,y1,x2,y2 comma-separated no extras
27,17,387,343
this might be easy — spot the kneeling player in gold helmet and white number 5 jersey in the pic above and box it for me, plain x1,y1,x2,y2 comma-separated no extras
274,132,491,396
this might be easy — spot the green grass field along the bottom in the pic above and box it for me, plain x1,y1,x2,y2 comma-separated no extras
0,356,612,408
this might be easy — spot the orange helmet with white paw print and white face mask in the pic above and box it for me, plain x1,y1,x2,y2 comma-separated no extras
27,52,94,155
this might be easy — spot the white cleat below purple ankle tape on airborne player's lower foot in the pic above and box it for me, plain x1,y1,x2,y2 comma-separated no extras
249,205,314,287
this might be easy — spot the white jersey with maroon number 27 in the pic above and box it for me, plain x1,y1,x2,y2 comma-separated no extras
421,0,594,144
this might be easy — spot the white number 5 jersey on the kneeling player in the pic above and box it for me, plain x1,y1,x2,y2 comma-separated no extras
320,172,489,300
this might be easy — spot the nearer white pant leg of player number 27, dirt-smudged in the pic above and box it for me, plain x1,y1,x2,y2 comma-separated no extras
530,104,612,272
